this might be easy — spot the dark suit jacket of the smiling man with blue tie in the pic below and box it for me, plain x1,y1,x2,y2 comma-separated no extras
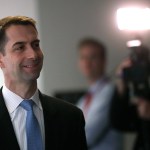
0,89,87,150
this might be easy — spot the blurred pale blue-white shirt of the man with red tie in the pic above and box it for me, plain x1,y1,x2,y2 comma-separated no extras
77,77,122,150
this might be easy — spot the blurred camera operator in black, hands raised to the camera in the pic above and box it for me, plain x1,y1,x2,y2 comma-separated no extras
111,58,150,150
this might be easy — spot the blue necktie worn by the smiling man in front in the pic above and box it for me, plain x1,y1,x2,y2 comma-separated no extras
20,100,43,150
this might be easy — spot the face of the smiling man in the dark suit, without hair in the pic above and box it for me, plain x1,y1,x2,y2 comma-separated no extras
0,25,43,83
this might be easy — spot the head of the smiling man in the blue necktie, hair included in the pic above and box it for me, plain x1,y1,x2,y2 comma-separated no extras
0,16,43,85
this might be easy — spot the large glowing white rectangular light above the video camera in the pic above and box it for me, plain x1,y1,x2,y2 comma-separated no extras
117,7,150,30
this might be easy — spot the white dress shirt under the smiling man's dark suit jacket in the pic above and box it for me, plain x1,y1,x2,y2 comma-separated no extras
2,85,45,150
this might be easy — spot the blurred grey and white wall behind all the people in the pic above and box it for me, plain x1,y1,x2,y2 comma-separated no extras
0,0,150,150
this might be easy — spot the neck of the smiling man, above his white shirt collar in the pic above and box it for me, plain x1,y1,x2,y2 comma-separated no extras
5,81,37,99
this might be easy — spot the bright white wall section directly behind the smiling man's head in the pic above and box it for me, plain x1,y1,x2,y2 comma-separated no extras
0,0,42,89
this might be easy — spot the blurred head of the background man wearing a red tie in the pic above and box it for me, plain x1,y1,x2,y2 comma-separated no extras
78,38,106,82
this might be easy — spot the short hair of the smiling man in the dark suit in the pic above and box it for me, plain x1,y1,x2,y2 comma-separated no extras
0,16,37,54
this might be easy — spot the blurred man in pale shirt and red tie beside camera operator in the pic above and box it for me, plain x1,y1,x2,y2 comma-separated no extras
77,38,122,150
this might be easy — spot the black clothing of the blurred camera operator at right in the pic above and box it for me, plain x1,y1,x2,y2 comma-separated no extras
110,89,150,150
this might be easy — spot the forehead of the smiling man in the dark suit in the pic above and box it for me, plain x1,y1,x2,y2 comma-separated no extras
6,25,38,42
